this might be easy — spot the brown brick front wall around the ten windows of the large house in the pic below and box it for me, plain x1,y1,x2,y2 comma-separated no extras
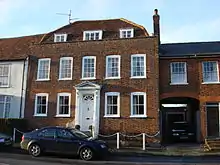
25,37,159,137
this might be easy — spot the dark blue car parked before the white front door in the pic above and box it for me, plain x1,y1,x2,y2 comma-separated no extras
20,127,108,160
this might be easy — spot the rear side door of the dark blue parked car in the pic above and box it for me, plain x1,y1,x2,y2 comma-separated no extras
37,128,56,152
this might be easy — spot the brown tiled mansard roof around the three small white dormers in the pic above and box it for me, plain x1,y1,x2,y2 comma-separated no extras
41,18,149,42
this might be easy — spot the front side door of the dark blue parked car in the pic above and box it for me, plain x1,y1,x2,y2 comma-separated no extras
56,129,80,154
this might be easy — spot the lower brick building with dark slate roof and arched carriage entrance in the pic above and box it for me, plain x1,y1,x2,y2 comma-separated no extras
159,42,220,142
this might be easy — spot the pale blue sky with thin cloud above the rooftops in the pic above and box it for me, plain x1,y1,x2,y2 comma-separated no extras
0,0,220,43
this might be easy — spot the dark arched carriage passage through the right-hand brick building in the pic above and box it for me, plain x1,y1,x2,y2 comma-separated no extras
160,97,200,143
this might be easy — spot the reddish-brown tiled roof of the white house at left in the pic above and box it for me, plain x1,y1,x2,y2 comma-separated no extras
0,34,43,60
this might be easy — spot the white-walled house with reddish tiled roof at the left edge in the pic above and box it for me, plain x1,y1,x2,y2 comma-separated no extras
0,36,42,118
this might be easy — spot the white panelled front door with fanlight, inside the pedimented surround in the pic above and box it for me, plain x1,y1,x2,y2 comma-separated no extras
80,94,94,131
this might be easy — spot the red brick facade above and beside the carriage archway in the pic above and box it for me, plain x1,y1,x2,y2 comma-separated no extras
159,57,220,141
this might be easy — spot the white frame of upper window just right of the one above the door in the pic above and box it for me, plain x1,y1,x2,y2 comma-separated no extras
105,55,121,79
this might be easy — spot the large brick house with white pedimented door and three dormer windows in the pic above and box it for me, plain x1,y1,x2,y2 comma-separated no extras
24,15,159,139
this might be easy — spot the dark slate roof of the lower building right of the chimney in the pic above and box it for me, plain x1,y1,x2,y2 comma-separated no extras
160,41,220,57
